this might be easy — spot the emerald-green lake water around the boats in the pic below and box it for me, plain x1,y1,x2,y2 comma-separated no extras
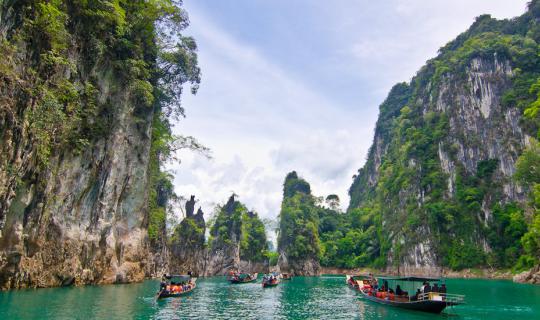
0,276,540,320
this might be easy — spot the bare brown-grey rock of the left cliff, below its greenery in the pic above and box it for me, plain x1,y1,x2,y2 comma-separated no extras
0,57,152,288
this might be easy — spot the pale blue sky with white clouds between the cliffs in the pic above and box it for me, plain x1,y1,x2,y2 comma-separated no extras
167,0,527,230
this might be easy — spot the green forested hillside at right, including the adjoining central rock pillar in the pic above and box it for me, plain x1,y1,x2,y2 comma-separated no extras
278,1,540,282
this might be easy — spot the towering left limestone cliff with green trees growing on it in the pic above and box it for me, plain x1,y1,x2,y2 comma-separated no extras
0,0,198,288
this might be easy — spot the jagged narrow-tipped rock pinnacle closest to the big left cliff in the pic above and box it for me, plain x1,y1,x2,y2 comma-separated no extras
169,196,207,275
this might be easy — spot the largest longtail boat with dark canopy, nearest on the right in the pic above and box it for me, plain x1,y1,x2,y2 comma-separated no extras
346,275,465,313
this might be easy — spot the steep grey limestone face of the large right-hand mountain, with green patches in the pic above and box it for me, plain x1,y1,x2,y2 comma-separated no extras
349,11,540,274
